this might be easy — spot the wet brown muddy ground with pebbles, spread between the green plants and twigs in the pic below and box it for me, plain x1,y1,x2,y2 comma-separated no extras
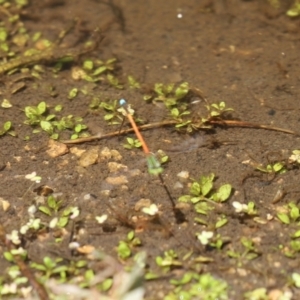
0,0,300,299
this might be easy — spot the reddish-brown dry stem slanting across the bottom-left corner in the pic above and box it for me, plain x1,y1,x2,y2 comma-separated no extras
0,224,50,300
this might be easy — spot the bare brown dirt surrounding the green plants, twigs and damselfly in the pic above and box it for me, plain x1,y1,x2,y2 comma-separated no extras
0,0,300,299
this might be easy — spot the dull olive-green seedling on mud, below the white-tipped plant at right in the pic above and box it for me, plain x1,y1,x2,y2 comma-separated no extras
226,237,260,267
